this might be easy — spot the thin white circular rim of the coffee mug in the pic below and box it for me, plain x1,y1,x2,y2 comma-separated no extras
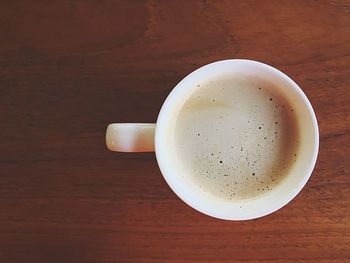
155,59,319,220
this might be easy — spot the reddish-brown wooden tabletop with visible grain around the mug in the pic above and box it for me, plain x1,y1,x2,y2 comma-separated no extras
0,0,350,263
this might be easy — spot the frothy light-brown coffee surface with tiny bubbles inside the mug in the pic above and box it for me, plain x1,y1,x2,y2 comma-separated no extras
174,76,299,200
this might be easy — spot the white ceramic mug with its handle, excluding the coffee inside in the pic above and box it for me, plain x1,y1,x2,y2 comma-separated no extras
106,59,319,220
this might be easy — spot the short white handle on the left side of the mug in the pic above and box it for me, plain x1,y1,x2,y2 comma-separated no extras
106,123,156,152
